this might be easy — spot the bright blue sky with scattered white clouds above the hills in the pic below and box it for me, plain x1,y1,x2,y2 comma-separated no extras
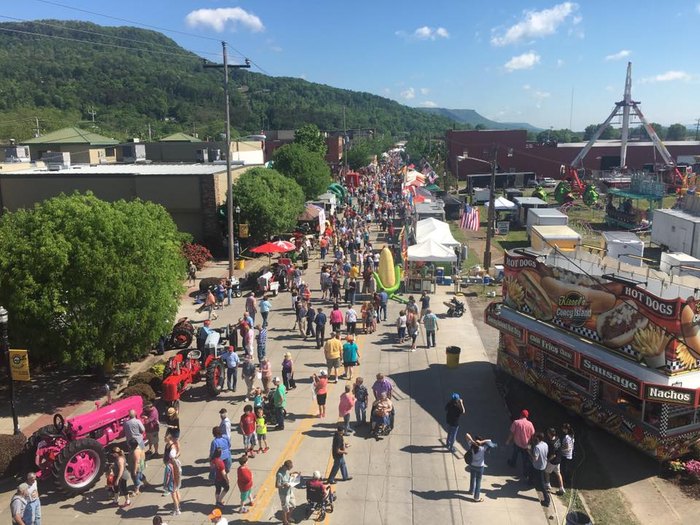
5,0,700,130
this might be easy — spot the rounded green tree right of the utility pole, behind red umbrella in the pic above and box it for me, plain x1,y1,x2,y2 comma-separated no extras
233,168,304,241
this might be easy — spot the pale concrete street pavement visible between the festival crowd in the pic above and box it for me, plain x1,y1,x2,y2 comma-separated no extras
0,249,552,525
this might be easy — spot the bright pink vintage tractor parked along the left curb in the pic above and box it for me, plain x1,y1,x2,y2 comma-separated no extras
27,396,143,494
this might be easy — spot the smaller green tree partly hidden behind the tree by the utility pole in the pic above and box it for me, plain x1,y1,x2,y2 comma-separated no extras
273,143,331,199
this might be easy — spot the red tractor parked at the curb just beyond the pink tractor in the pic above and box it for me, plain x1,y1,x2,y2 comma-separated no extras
163,331,226,408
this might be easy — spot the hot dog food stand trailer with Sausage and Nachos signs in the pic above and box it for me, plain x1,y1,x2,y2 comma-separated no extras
484,249,700,460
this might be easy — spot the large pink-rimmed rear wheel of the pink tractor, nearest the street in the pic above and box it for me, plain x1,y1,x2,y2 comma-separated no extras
53,438,105,494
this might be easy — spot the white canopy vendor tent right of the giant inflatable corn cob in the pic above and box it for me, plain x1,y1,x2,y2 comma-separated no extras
404,239,457,293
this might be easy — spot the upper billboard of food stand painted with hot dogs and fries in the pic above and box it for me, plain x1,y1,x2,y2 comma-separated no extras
503,253,700,374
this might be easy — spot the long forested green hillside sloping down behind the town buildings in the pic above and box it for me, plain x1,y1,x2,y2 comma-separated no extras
0,20,452,141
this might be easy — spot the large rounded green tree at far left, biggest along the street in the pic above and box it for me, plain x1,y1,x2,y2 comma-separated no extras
0,193,185,368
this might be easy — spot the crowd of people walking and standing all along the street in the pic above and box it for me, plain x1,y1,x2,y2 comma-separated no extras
12,152,574,525
